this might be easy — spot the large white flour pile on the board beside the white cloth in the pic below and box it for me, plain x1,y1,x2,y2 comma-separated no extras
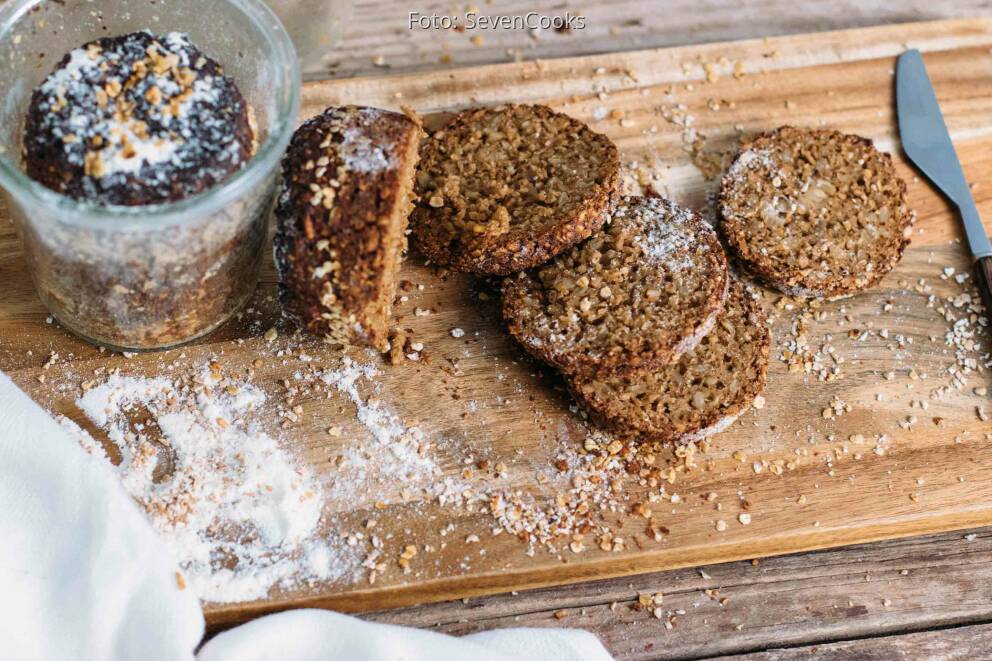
63,363,359,602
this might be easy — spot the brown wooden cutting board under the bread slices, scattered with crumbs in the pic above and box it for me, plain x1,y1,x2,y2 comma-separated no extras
0,19,992,626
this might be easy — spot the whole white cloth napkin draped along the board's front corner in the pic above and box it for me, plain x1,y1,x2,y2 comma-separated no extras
0,373,611,661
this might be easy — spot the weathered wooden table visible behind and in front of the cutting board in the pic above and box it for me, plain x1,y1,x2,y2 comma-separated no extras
308,0,992,659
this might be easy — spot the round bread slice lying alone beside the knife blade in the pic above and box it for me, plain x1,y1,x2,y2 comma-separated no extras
720,126,913,297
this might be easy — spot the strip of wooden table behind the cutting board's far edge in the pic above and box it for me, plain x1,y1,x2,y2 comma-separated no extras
316,0,992,79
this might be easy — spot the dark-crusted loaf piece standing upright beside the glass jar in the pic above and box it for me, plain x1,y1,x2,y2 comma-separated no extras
275,106,423,351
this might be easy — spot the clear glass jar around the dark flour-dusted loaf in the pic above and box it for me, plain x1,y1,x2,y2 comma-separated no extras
0,0,300,350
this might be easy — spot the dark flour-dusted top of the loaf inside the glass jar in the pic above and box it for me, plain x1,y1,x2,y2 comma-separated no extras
24,31,253,206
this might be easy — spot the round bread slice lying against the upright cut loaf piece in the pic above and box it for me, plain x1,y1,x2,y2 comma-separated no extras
411,105,620,275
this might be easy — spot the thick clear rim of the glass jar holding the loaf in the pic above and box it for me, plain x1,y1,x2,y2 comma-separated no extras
0,0,302,230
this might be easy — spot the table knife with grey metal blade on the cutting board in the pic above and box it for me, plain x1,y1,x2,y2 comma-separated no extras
896,49,992,320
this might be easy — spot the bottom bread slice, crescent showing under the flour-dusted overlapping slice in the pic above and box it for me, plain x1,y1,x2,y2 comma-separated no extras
569,279,771,443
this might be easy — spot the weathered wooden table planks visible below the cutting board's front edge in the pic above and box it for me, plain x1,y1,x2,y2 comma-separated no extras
364,528,992,660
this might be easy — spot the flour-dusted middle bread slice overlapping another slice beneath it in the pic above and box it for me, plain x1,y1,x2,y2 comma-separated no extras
503,197,728,377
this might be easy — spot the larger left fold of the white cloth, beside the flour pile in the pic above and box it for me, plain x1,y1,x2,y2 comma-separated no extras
0,374,203,661
